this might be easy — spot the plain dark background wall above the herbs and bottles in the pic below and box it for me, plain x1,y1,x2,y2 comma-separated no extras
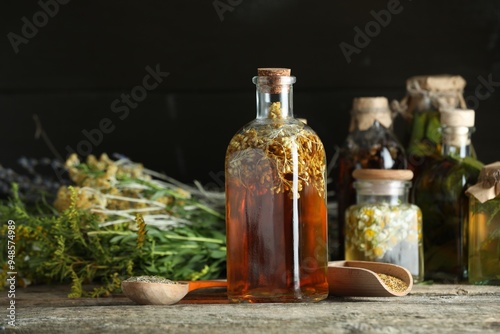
0,0,500,186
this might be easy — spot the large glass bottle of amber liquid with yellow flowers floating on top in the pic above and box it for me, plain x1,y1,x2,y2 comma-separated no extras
225,68,328,303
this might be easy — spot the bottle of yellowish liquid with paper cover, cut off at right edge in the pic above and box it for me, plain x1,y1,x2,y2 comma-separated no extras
466,161,500,285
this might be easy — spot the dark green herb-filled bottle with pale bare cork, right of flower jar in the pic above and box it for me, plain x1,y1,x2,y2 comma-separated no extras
413,109,482,283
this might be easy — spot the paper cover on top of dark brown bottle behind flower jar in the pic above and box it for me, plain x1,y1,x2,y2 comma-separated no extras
349,96,392,132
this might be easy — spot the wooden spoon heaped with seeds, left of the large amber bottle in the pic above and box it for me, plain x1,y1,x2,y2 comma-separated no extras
122,280,227,305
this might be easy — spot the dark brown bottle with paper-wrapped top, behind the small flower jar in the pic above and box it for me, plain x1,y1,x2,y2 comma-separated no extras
329,96,407,260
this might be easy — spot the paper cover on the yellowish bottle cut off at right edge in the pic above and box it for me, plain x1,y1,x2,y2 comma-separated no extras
465,161,500,203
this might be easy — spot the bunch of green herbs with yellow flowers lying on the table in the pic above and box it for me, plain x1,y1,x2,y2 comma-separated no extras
0,155,226,297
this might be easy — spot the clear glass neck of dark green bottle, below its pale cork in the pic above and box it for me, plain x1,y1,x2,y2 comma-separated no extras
441,126,474,158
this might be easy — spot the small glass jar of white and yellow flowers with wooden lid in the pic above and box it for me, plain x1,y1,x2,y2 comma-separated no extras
345,169,424,282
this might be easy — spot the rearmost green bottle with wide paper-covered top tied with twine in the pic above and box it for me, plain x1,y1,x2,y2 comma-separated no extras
393,74,466,180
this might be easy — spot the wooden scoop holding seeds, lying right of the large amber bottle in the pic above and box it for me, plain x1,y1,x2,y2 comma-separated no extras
328,261,413,297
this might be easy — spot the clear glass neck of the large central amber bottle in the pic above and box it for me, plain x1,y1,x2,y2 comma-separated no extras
253,76,295,119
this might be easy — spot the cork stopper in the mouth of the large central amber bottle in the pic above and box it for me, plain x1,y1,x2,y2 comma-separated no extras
254,67,295,94
